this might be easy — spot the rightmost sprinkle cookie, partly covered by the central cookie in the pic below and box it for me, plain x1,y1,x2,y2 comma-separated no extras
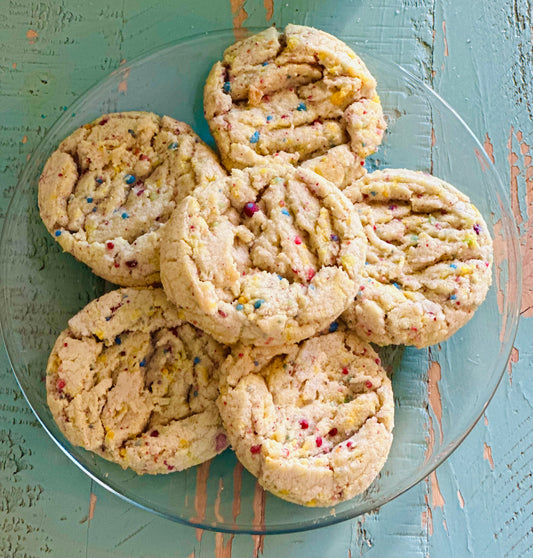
343,169,493,348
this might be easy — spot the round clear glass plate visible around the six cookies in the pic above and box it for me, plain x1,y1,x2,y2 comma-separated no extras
0,31,520,533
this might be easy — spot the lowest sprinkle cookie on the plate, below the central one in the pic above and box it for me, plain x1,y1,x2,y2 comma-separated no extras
218,330,394,506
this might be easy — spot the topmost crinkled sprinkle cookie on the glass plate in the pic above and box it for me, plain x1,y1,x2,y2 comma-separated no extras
204,25,385,186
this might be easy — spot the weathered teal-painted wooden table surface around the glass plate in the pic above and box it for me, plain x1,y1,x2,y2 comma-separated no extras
0,0,533,558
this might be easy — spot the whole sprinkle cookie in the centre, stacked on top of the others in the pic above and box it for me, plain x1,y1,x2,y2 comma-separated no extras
161,164,366,345
